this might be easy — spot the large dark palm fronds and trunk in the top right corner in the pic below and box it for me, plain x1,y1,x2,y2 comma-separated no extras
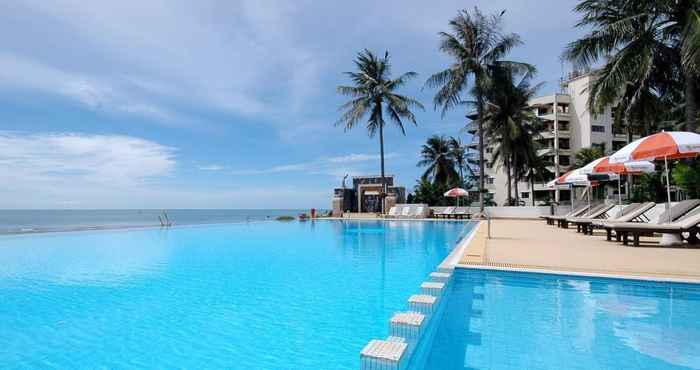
564,0,700,132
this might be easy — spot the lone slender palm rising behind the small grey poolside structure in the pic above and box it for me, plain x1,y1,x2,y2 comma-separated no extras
336,49,423,212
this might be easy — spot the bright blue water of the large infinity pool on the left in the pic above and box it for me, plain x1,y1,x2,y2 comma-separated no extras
0,220,471,369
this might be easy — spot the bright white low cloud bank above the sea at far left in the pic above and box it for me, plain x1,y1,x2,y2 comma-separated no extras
0,132,175,188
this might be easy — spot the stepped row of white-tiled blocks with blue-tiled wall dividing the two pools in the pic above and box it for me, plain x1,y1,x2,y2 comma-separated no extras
360,265,454,370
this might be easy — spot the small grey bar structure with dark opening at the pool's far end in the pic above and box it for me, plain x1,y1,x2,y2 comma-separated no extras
333,176,406,217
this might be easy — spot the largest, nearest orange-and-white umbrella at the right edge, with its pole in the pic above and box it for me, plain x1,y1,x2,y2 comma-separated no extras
610,131,700,221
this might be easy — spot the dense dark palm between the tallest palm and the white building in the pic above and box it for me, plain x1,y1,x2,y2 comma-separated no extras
484,64,544,203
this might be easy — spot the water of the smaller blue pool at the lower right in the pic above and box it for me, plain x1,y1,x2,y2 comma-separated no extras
427,270,700,370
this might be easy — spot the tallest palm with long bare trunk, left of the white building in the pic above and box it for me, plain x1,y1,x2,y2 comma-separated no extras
426,8,522,212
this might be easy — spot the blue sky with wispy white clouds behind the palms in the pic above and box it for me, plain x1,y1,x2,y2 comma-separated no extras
0,0,582,209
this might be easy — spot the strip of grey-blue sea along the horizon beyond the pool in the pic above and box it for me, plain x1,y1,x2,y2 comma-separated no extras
0,209,308,233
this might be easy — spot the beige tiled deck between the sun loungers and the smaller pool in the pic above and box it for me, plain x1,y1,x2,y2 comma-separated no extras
460,219,700,282
